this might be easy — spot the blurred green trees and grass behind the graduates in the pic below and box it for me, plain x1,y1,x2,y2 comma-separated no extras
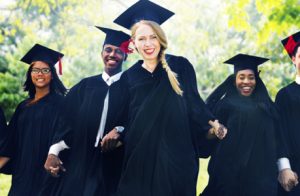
0,0,300,195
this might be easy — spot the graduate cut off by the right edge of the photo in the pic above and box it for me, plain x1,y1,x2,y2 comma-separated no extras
275,32,300,195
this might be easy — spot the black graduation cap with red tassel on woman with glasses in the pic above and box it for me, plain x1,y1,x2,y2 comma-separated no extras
21,44,64,75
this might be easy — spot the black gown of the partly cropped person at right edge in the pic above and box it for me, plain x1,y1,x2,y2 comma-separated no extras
275,82,300,195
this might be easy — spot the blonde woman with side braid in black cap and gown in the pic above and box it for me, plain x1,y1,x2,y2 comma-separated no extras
114,0,226,196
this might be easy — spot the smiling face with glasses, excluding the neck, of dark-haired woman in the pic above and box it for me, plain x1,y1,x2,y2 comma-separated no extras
31,61,52,90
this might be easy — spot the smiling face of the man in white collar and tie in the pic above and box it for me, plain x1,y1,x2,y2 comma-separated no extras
101,44,125,76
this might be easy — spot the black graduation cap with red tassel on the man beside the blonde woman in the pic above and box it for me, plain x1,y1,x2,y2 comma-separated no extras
96,26,133,54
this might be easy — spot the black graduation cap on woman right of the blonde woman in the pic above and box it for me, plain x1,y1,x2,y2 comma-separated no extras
224,54,269,73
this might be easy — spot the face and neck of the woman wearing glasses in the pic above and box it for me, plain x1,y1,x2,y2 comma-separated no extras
31,61,52,102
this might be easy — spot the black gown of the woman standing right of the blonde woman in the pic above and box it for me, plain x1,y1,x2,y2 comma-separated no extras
201,95,277,196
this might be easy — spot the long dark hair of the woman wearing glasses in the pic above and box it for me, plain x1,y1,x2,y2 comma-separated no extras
23,62,67,99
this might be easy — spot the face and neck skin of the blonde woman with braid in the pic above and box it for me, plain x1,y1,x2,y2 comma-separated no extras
133,24,161,73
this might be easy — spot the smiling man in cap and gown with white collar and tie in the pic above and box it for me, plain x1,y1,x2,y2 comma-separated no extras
41,27,130,196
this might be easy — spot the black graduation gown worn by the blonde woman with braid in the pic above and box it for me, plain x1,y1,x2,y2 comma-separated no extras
117,55,212,196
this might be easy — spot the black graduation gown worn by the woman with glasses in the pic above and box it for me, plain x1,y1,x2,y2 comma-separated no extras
7,93,63,196
